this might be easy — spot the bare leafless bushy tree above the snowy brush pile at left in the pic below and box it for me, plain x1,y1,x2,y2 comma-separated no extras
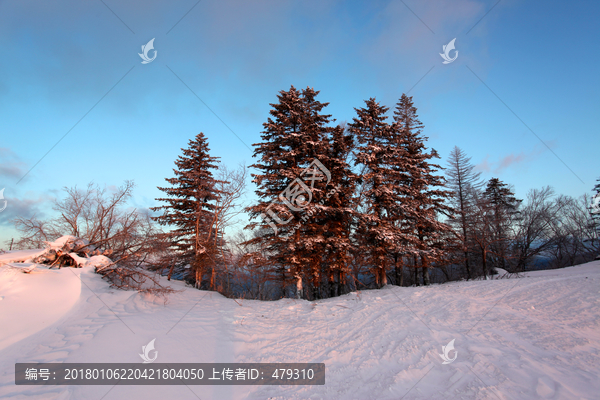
14,181,172,294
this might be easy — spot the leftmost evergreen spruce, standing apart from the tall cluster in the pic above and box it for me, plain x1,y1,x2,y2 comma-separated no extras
151,133,222,289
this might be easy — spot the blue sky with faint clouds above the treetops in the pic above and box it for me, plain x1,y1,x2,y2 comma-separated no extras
0,0,600,247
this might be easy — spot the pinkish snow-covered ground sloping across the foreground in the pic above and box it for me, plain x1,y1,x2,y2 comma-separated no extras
0,254,600,400
